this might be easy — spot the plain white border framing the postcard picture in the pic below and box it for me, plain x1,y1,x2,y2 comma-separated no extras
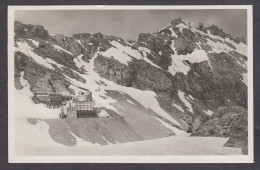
8,5,254,163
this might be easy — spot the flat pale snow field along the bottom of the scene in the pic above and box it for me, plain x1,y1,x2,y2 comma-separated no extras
16,136,242,156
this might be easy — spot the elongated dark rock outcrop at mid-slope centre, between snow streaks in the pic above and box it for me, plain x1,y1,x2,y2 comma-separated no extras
94,56,172,91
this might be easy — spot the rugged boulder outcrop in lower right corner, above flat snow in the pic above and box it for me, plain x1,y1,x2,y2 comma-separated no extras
191,106,248,154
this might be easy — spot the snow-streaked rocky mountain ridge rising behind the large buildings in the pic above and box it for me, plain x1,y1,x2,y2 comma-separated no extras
15,18,247,151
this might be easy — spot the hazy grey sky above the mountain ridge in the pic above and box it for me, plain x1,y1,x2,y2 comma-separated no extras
15,9,247,40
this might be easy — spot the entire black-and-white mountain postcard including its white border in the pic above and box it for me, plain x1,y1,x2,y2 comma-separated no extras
8,5,254,163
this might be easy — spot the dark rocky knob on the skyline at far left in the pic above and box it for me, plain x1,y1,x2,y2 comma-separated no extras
14,21,49,39
